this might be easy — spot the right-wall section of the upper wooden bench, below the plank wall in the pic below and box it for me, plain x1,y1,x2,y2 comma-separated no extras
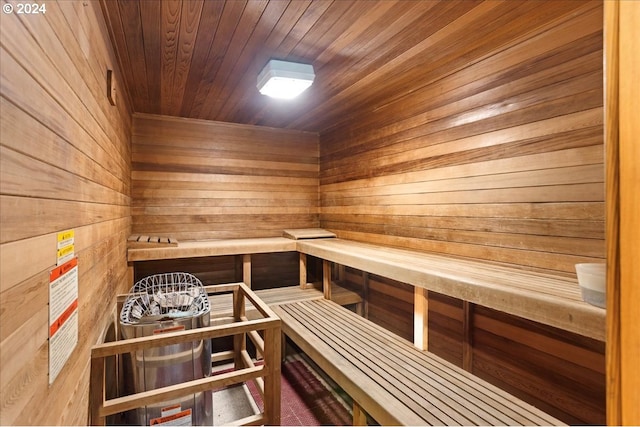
296,239,606,341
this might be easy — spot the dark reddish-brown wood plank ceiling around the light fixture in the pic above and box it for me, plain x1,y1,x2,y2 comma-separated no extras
101,0,596,132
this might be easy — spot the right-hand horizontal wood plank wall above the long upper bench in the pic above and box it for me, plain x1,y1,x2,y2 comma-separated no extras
320,1,604,274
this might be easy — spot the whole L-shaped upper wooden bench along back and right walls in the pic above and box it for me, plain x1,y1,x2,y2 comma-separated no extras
128,229,606,342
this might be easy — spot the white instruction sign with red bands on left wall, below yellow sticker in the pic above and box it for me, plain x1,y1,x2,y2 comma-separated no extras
49,257,78,385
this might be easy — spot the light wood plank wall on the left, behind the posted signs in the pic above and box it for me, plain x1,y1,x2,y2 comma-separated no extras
0,1,131,425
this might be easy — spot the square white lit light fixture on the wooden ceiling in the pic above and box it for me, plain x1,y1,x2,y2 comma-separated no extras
257,59,315,99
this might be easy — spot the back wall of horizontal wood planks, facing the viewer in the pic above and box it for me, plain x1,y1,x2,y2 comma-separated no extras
132,114,319,241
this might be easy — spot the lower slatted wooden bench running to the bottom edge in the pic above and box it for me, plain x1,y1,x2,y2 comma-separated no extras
273,299,563,425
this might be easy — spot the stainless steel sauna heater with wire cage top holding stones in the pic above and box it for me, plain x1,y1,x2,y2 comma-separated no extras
120,273,213,426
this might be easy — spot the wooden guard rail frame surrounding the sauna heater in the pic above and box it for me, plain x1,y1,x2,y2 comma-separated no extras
90,283,282,425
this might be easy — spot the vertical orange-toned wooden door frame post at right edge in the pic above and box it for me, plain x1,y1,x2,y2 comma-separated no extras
605,2,640,425
